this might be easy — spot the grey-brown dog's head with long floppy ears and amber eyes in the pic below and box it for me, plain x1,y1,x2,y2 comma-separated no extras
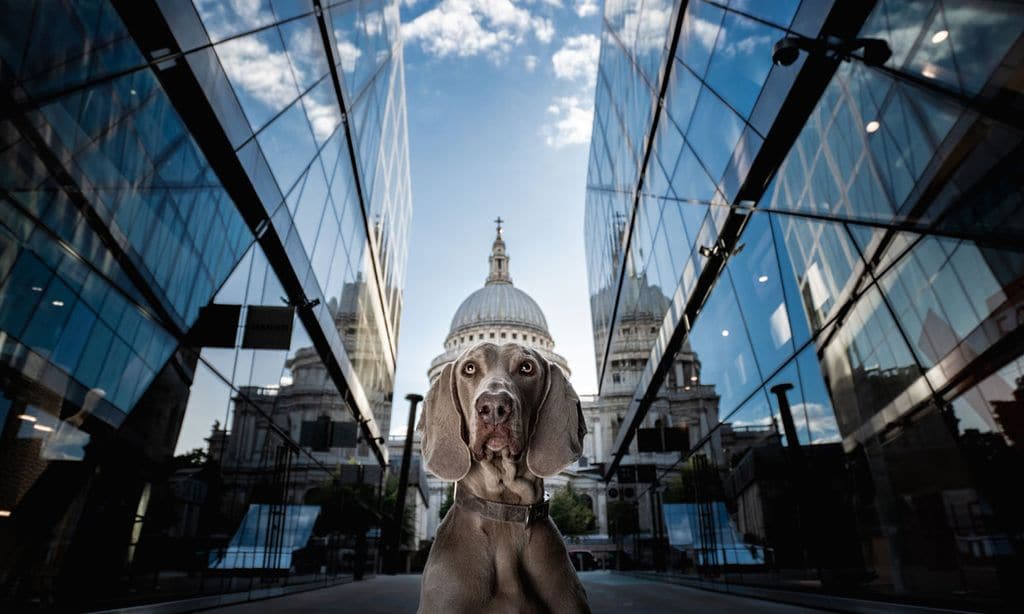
420,343,587,481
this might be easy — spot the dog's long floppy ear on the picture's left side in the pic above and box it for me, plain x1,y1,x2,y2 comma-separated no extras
420,364,470,482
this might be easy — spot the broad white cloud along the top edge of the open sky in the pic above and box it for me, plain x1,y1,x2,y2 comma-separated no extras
401,0,555,62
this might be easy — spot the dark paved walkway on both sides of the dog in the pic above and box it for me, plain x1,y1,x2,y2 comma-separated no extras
219,571,814,614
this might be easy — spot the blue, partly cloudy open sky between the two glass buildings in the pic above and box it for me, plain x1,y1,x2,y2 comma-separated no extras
391,0,600,434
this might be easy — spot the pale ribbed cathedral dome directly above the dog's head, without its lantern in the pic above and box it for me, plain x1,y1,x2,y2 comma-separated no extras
449,283,551,337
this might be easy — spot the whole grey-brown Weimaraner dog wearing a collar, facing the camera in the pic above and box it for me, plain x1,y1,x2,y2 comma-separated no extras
420,343,590,614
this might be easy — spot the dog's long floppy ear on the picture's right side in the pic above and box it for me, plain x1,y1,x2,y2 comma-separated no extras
526,362,587,478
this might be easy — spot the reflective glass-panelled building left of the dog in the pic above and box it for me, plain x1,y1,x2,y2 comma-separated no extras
0,0,412,611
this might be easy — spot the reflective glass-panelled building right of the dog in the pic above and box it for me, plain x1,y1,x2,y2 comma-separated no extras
585,0,1024,608
